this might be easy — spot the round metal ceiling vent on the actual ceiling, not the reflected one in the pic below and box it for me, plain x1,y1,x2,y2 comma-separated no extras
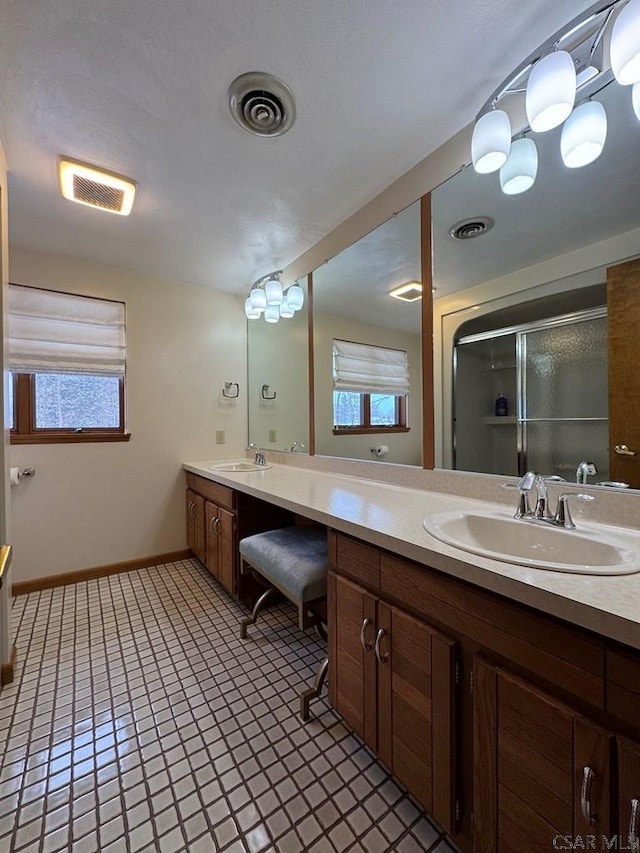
227,71,296,136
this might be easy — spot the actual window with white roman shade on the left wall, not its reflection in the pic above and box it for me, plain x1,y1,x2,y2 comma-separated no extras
7,284,129,444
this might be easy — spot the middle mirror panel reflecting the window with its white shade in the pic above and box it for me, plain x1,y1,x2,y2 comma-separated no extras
313,201,422,465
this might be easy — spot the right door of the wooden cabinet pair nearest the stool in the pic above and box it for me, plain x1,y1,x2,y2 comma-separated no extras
374,602,456,832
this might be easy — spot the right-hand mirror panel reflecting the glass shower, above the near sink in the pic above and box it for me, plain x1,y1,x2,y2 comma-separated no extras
432,77,640,488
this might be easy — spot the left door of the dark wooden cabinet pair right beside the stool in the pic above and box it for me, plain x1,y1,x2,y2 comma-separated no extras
329,573,377,750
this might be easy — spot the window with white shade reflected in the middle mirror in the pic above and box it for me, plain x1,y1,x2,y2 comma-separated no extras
333,340,409,434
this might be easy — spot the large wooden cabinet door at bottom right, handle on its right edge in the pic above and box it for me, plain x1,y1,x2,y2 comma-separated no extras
473,660,612,853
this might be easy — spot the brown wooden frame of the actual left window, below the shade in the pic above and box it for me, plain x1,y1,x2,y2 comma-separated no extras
9,371,131,444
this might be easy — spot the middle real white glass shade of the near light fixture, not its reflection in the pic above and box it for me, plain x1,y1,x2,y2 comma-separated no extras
525,50,576,133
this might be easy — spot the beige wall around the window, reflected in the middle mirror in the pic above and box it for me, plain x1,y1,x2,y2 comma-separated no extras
313,313,422,465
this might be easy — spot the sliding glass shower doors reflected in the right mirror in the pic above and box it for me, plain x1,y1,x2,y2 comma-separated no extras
453,308,608,480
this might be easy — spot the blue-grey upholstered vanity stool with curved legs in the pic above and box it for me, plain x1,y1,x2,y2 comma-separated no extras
240,526,328,720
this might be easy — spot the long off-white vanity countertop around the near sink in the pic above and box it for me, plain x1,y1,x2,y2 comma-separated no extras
183,462,640,649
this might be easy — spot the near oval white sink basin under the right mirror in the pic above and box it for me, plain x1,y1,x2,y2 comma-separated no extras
423,511,640,575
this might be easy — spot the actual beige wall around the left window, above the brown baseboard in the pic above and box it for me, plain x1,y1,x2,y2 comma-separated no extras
10,246,247,582
